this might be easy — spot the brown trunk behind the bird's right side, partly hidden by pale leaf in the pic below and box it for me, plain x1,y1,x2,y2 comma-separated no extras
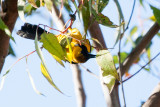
89,22,120,107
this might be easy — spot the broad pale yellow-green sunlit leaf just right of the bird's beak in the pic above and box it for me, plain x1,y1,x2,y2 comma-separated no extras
96,50,119,92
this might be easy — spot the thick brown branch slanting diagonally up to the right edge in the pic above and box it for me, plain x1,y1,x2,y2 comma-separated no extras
118,22,160,75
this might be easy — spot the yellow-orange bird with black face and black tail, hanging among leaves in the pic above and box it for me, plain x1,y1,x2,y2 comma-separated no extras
17,23,95,63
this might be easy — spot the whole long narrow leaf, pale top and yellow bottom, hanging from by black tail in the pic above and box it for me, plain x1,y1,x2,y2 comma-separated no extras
35,32,63,94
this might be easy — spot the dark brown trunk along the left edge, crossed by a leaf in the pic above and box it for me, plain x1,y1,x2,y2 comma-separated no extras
0,0,18,73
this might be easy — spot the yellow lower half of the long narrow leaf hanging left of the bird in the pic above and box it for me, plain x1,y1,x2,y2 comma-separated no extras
40,63,63,94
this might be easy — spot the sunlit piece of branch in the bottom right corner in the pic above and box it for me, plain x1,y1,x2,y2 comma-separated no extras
142,83,160,107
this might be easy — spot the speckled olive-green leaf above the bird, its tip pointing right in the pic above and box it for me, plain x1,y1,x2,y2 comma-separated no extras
92,9,118,28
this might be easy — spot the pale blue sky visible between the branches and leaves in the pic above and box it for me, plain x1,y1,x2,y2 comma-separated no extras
0,0,160,107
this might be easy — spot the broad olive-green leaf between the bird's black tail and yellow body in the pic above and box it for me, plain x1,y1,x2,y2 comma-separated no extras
40,32,66,60
